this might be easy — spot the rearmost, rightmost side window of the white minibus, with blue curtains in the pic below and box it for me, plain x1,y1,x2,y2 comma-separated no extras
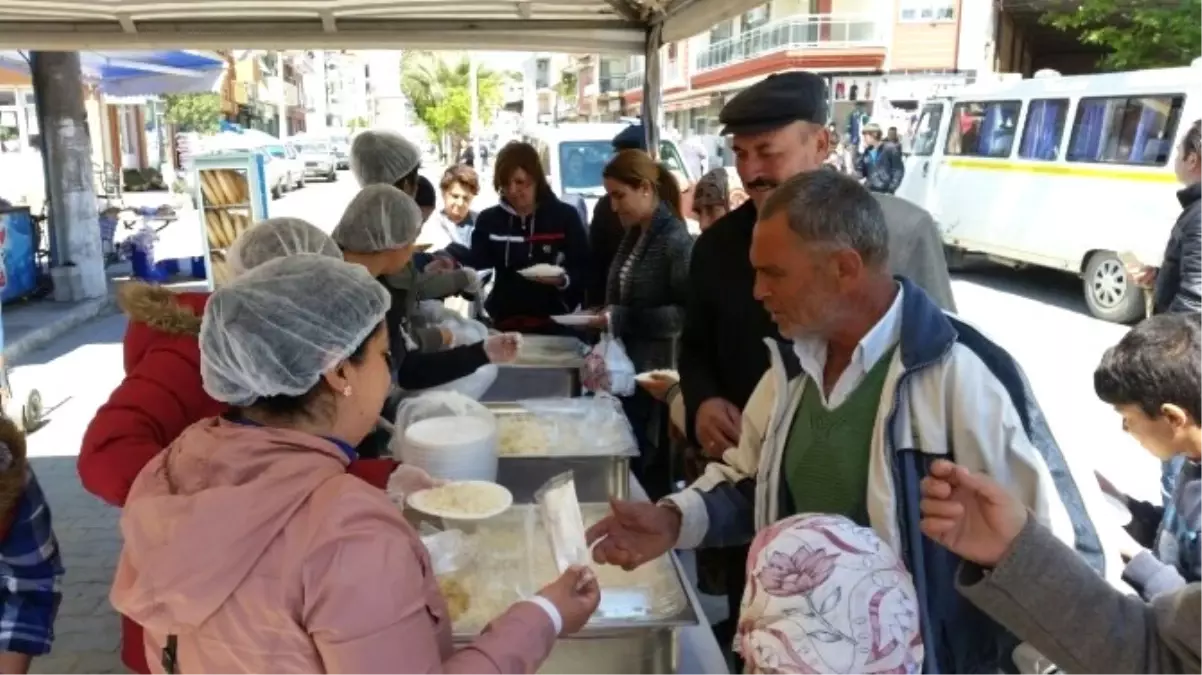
1069,94,1185,167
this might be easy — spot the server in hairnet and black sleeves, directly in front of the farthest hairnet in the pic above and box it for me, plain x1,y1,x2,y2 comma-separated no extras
331,185,518,389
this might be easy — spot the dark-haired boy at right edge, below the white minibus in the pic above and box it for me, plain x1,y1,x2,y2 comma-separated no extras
1094,313,1202,598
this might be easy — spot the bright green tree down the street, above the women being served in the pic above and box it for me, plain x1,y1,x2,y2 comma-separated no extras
400,52,505,139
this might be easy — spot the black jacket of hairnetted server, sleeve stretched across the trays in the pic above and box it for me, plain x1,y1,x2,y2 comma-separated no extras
380,279,489,389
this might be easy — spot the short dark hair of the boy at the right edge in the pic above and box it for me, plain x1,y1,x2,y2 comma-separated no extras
1094,313,1202,422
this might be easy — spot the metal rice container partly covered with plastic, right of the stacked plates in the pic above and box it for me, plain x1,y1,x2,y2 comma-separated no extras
487,395,638,504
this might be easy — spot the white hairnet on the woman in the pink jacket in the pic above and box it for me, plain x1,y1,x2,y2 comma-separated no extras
200,253,389,406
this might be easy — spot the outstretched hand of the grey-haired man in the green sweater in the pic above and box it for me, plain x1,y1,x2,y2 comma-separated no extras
585,498,680,571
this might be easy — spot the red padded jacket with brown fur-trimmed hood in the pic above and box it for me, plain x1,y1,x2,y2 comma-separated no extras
78,283,397,675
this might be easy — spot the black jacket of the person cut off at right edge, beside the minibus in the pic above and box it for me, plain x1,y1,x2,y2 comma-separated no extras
1153,183,1202,313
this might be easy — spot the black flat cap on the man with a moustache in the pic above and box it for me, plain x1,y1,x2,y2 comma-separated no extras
718,71,829,136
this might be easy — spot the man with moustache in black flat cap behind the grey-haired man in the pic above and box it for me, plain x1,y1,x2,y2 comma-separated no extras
679,72,954,658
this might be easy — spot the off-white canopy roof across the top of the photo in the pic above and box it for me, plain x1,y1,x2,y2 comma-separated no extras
0,0,762,53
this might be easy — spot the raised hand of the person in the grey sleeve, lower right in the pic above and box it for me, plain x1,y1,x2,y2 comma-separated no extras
920,459,1028,567
